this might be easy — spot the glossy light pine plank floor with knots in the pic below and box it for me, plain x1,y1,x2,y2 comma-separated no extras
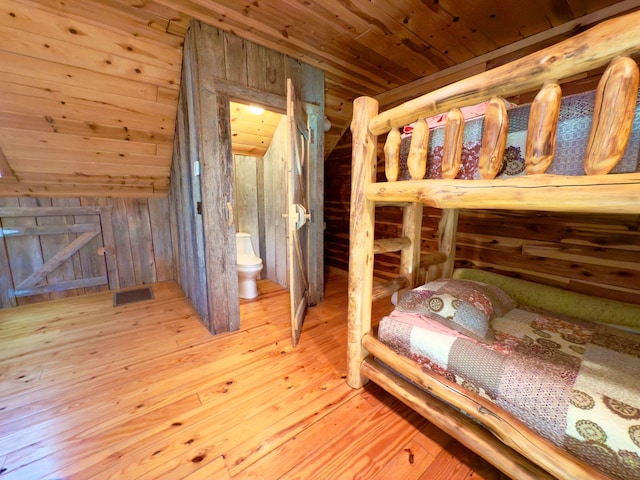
0,274,506,480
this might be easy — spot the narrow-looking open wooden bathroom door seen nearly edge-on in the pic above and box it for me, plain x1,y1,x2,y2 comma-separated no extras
287,78,311,346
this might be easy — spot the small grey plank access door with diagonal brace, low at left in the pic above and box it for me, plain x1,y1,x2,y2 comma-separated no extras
0,206,118,308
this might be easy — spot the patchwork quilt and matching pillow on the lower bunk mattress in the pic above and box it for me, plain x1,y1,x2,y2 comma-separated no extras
378,279,640,480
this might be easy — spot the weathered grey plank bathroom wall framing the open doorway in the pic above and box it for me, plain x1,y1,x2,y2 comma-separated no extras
170,20,325,334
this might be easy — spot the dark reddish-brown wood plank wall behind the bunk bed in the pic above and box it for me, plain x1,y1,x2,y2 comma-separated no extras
325,133,640,304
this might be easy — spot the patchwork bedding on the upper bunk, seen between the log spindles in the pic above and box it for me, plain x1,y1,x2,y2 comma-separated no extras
398,91,640,180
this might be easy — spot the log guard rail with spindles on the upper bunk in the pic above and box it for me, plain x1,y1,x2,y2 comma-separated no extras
351,11,640,213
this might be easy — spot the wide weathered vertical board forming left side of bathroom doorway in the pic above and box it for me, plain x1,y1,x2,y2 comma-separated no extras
187,22,240,333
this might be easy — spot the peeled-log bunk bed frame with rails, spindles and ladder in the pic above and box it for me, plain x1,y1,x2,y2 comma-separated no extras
348,11,640,479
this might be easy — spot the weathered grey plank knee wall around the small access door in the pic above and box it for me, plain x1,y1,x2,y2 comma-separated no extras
0,197,175,308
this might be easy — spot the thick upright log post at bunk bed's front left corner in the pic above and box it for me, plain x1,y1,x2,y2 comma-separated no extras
347,97,378,388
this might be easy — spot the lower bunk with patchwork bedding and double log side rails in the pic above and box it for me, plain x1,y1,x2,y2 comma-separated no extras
352,269,640,480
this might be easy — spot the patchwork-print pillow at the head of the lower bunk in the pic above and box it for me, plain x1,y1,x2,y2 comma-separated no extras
396,279,516,343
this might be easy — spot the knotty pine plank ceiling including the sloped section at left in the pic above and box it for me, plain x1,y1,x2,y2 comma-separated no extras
0,0,640,197
